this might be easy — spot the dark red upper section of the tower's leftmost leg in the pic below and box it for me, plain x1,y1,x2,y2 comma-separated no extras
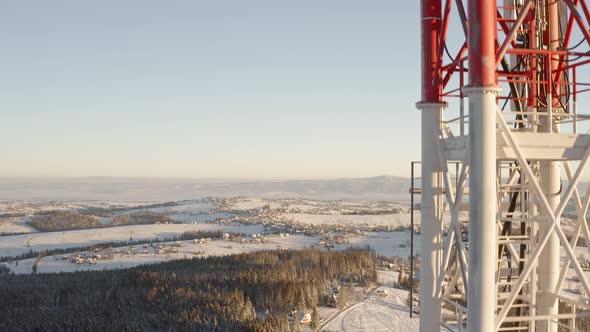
420,0,442,103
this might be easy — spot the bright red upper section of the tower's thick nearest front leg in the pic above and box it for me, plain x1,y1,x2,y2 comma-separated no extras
467,0,498,87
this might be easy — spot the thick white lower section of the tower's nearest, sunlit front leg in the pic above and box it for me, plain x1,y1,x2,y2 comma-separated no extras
464,87,500,332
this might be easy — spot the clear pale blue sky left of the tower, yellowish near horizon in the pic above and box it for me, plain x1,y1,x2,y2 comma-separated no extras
0,0,420,178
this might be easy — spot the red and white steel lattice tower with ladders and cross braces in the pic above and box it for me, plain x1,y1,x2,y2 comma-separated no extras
417,0,590,332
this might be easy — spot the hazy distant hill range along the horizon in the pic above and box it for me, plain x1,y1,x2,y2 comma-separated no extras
0,176,409,201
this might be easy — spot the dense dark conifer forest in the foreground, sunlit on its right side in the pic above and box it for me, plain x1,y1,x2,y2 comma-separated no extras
0,249,376,331
